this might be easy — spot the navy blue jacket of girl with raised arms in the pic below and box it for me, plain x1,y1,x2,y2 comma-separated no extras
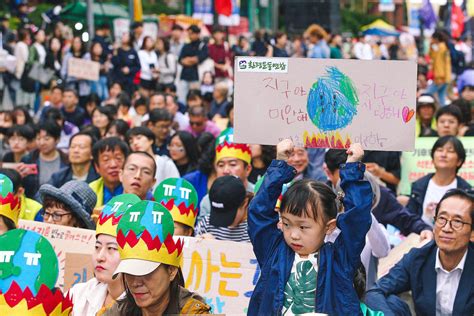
248,160,372,315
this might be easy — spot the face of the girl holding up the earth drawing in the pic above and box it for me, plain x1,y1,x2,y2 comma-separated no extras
281,212,328,258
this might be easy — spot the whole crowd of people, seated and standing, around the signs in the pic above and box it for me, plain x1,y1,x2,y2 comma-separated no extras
0,9,474,315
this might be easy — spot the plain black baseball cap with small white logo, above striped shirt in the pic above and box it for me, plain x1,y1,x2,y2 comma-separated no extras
209,176,246,227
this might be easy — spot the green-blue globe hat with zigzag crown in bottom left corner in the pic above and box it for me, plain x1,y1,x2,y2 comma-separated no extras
0,229,72,316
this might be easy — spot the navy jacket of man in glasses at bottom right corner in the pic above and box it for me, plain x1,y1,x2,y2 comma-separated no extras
366,241,474,316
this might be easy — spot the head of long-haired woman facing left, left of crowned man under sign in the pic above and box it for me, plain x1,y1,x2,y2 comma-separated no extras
168,131,199,176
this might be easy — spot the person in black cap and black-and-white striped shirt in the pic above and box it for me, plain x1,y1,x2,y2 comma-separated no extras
195,176,253,242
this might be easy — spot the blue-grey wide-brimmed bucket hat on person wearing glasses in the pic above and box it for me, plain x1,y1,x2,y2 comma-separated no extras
39,180,97,229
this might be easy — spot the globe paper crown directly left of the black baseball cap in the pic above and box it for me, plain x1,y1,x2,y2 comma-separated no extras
153,178,198,228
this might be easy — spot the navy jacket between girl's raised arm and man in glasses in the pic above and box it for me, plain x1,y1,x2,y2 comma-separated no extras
372,187,432,236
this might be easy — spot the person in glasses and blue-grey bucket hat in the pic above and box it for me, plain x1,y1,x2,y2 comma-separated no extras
39,180,97,229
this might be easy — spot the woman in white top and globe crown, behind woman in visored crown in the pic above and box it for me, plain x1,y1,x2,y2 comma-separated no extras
69,194,140,315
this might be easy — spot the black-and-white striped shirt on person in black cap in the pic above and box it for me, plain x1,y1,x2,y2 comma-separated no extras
195,215,250,242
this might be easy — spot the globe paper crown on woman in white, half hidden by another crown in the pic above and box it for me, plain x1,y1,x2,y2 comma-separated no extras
95,194,141,237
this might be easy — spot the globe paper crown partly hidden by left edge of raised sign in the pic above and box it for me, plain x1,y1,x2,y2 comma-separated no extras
216,127,252,164
